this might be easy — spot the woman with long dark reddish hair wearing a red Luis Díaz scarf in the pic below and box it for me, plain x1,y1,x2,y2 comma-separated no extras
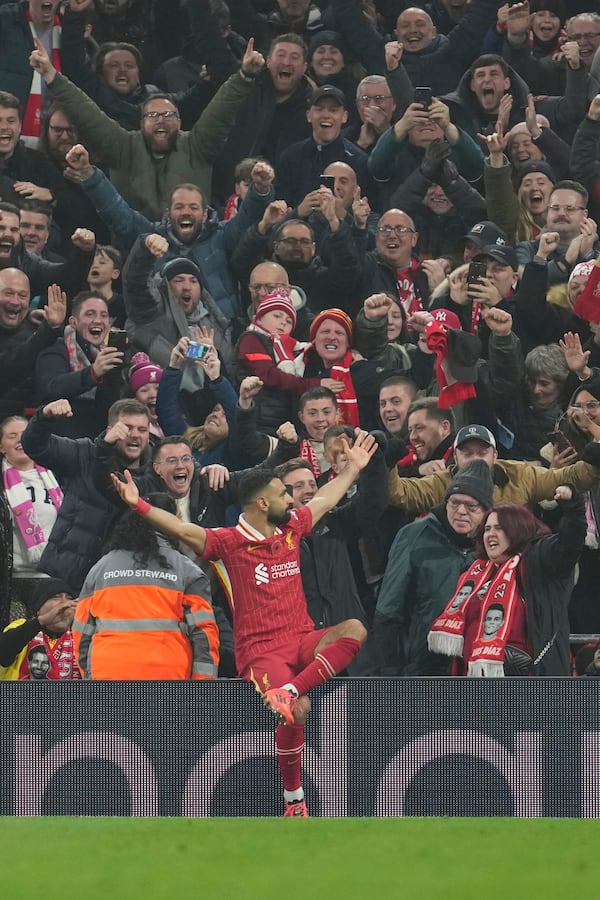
428,485,586,678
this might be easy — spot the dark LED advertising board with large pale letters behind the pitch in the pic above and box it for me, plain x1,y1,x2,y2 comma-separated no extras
0,678,600,818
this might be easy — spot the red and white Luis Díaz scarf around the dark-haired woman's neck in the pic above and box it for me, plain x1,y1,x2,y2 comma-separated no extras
427,553,521,678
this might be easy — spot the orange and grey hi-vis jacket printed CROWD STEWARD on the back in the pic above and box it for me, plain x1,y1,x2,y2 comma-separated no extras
72,536,219,681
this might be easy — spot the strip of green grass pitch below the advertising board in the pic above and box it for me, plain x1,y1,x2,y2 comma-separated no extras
0,818,600,900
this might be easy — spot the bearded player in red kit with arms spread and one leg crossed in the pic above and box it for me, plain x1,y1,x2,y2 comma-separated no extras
112,429,377,817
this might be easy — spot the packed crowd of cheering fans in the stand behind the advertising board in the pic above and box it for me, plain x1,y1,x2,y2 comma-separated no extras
0,0,600,680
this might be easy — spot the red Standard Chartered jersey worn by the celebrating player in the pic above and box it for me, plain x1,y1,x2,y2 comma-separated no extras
202,507,315,672
